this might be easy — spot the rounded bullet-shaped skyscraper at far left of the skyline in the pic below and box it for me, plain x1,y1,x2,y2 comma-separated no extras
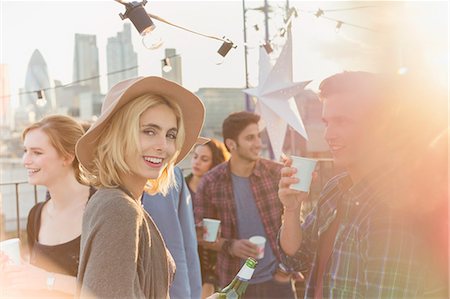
19,49,56,123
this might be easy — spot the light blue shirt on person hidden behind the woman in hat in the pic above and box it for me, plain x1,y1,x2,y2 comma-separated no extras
142,167,202,299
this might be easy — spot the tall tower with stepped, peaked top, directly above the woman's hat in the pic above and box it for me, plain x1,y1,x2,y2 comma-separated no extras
106,23,138,89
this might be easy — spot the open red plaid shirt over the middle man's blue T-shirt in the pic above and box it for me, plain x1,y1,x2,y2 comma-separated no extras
194,159,282,286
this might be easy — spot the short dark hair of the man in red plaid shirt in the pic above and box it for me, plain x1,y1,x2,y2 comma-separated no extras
222,111,260,150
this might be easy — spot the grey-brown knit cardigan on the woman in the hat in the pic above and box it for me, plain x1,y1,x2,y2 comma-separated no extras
77,188,175,299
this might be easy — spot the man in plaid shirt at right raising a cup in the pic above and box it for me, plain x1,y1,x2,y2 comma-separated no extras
279,72,440,299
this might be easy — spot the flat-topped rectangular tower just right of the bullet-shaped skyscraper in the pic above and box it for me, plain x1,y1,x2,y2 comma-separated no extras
73,33,100,94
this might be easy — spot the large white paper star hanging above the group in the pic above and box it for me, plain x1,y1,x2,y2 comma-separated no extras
244,32,311,160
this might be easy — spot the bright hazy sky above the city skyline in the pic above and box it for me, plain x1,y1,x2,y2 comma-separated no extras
0,0,448,108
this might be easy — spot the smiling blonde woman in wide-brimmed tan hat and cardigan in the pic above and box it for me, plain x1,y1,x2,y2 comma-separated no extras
76,77,204,298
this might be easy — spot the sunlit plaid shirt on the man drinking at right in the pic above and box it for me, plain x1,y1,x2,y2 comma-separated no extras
281,171,423,299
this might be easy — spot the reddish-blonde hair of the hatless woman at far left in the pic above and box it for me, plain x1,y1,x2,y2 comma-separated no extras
22,115,87,184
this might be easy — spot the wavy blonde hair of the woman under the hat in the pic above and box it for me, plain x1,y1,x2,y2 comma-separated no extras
90,94,185,195
